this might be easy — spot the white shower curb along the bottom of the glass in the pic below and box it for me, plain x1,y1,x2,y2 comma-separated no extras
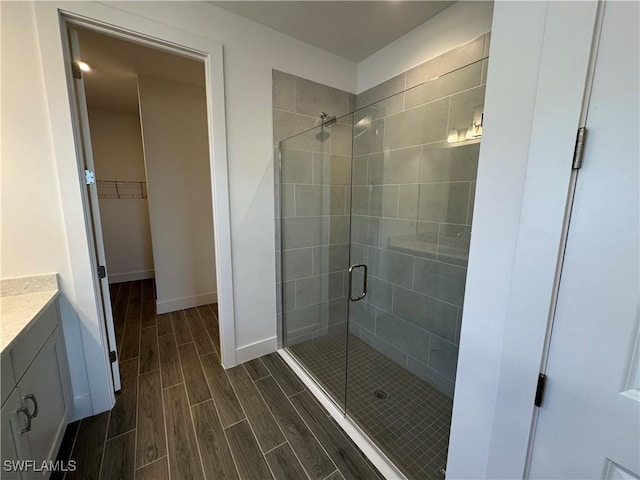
278,348,407,480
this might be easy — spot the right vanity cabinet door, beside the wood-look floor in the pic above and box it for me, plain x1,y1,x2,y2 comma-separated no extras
17,328,69,476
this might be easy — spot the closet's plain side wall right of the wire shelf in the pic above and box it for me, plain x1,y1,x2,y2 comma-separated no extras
138,75,216,313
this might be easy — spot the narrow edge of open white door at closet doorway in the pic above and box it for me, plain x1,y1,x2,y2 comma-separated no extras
69,28,121,391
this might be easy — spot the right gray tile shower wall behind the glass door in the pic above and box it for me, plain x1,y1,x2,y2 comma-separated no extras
350,34,489,397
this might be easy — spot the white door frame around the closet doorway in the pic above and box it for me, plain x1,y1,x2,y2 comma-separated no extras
34,2,236,414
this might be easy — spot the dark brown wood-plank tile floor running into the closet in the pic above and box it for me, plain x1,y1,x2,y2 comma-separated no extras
51,279,382,480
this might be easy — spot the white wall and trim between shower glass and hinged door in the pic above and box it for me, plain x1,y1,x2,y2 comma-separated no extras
447,1,597,479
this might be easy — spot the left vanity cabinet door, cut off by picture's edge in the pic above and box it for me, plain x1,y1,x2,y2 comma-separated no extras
0,390,31,480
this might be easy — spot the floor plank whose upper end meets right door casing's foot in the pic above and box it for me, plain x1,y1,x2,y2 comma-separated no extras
227,365,285,452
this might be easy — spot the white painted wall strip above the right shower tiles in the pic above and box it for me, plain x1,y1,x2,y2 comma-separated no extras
357,1,493,93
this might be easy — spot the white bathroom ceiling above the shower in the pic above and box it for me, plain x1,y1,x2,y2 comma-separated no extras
209,0,454,62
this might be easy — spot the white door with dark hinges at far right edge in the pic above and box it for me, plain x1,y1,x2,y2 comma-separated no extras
529,1,640,479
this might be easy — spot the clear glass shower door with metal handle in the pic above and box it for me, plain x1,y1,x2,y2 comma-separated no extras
346,62,484,479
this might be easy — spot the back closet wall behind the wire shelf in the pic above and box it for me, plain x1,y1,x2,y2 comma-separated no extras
89,108,153,283
